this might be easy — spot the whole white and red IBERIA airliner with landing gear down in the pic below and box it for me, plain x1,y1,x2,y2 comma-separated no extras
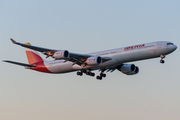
4,38,177,80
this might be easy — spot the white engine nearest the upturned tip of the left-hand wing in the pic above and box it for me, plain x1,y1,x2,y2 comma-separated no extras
53,50,69,59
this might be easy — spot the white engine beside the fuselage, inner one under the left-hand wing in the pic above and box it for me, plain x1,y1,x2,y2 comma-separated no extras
86,56,102,65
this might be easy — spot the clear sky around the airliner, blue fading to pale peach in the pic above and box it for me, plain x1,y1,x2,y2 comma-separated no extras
0,0,180,120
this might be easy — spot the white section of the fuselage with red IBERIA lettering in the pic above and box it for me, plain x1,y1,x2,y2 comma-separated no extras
44,41,177,73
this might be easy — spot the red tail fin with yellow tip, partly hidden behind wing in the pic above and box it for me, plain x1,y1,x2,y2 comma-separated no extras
25,43,44,64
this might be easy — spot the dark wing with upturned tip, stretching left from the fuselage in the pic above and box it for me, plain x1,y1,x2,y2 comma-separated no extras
10,38,112,65
